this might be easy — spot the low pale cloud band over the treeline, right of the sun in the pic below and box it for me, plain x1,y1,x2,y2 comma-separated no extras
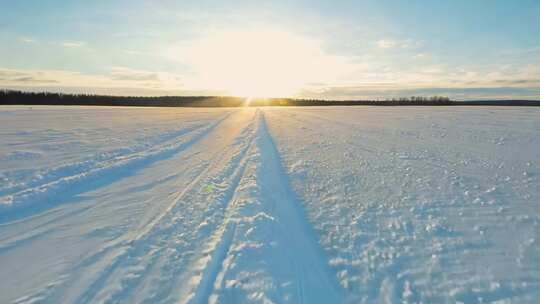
297,60,540,99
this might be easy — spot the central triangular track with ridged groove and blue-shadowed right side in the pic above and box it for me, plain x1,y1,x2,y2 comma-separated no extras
186,110,344,303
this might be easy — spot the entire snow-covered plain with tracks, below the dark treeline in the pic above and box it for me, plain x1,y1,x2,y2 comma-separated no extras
0,107,540,303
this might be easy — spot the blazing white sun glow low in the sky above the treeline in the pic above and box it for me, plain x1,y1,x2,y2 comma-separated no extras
173,29,350,97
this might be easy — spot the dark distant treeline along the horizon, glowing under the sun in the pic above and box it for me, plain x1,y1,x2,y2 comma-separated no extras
0,90,540,107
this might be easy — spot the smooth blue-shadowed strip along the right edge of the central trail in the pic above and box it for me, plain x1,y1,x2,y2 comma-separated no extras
252,115,344,303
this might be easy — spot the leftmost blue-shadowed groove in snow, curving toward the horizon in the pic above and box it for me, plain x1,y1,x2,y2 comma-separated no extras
0,112,235,223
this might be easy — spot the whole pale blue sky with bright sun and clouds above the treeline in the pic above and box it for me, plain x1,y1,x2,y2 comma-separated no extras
0,0,540,100
